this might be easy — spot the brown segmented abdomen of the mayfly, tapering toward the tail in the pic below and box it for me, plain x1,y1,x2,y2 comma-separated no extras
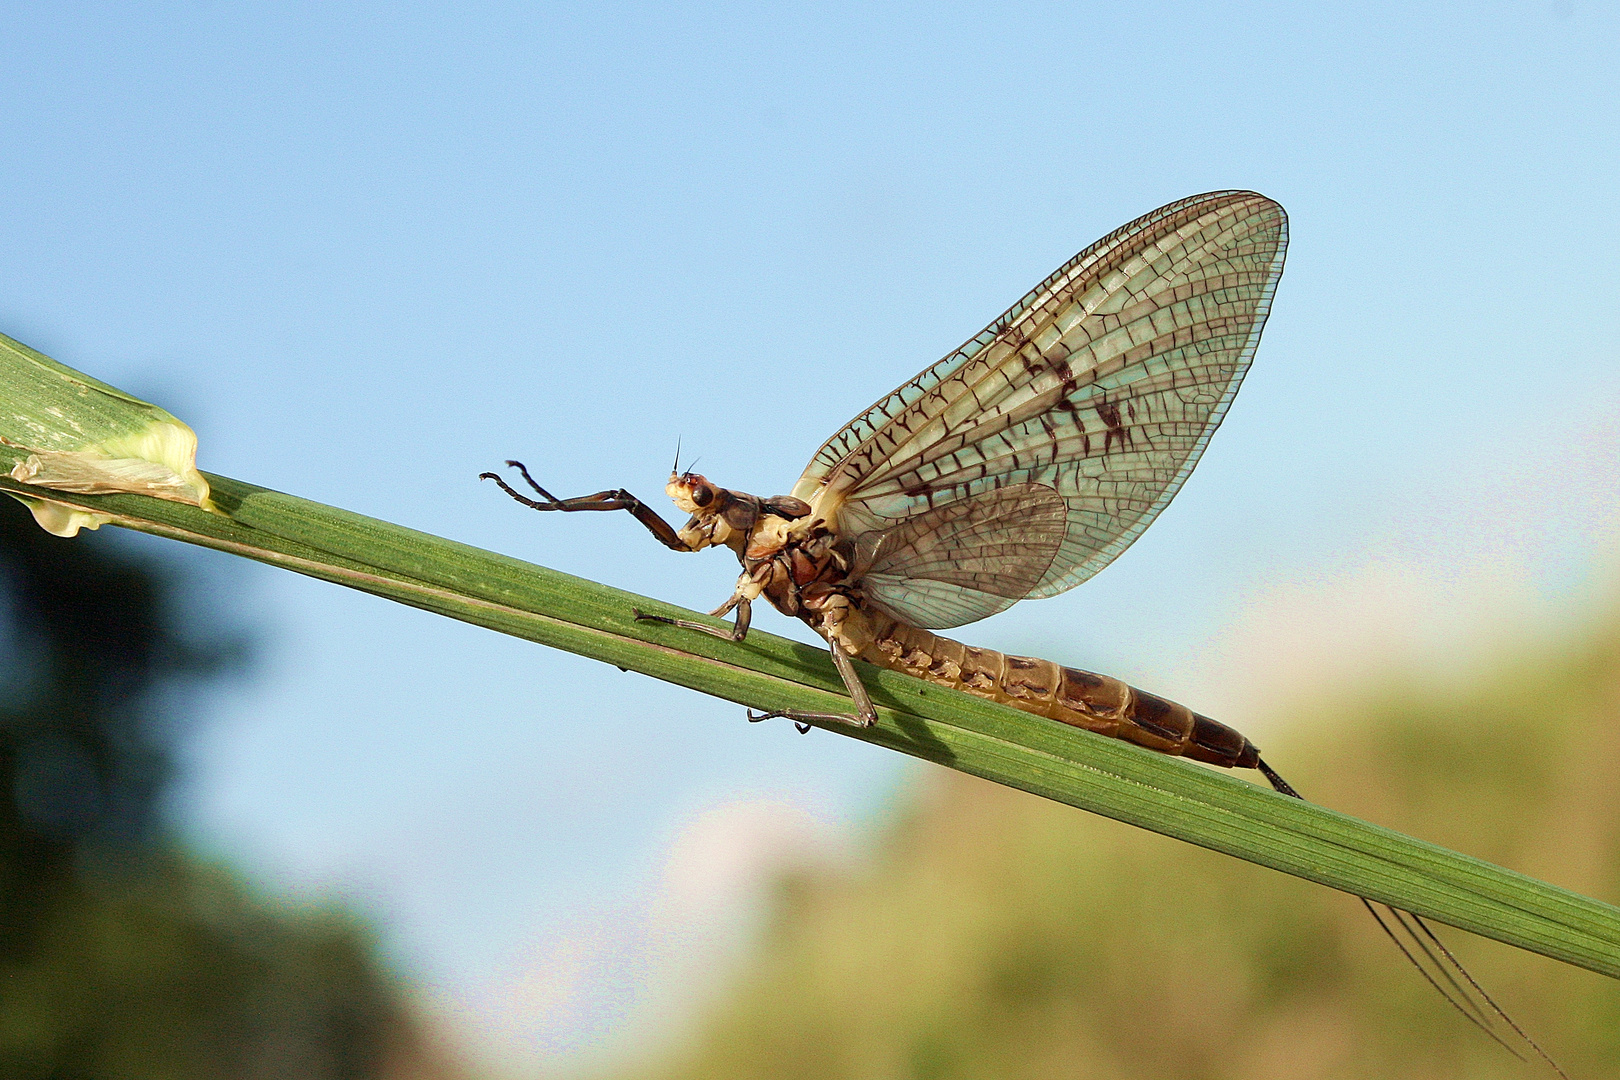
859,610,1259,769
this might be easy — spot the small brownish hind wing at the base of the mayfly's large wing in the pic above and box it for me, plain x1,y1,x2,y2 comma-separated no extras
855,484,1066,630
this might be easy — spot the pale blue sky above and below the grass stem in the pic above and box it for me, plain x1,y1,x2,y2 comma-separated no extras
0,0,1620,1064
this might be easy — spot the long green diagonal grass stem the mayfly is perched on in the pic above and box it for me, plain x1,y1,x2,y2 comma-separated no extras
0,476,1620,978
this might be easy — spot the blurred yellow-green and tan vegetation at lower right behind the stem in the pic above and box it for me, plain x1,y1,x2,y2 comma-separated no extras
605,605,1620,1080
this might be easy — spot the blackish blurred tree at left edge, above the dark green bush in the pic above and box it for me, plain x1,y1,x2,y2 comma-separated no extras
0,488,233,962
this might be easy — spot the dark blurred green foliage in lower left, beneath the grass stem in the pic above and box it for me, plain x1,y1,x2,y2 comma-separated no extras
0,499,434,1080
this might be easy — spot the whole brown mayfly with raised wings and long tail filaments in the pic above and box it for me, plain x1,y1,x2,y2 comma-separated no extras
483,191,1557,1069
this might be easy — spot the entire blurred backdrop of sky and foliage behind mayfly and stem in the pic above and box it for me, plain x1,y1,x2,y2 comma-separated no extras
0,0,1620,1080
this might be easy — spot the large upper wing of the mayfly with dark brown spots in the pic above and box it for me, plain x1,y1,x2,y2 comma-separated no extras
794,191,1288,628
